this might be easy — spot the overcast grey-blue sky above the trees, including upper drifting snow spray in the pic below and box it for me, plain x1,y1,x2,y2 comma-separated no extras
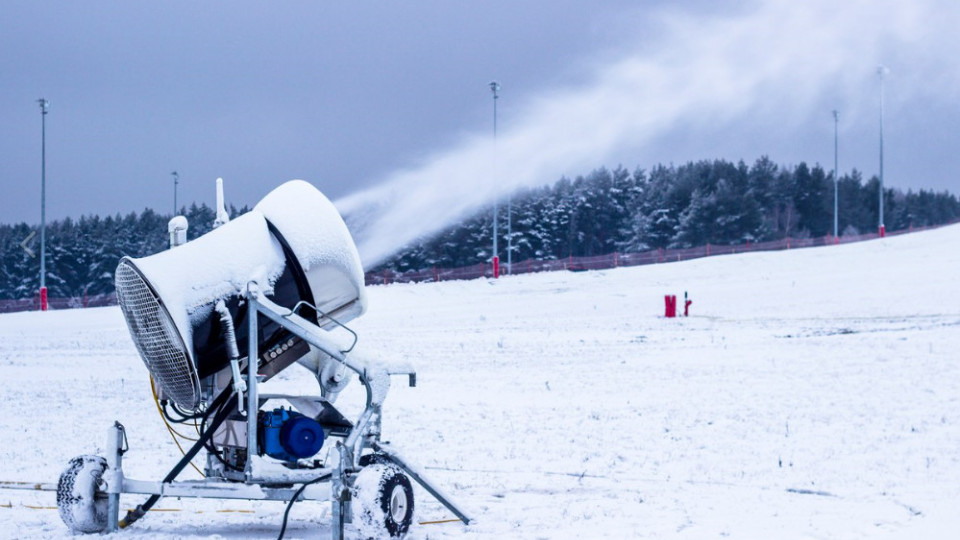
0,0,960,230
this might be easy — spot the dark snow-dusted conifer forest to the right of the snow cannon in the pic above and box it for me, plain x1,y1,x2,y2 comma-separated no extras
381,157,960,271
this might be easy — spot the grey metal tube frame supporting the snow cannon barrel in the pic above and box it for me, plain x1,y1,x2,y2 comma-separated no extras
100,283,471,540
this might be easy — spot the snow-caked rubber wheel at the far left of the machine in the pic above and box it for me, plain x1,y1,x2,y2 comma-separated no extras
57,456,107,533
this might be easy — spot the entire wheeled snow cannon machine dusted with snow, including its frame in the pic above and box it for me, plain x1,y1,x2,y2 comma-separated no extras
57,180,469,539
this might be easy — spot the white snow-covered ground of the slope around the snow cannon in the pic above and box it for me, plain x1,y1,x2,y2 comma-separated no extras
0,226,960,539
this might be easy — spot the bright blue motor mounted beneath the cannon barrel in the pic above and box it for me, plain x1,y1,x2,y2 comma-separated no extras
258,408,323,462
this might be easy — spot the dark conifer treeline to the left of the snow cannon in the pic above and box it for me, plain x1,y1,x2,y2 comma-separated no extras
0,204,242,298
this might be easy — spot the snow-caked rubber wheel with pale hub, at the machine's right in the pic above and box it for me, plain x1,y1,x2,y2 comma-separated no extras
351,463,413,538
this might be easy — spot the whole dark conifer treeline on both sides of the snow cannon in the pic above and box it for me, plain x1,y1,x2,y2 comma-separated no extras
0,157,960,298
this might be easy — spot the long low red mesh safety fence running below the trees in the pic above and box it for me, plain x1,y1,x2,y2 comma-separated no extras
0,220,960,313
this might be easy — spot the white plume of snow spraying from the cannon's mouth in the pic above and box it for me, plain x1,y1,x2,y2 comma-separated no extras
337,0,960,268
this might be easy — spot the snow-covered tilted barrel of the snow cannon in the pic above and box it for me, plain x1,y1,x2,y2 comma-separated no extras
115,180,366,411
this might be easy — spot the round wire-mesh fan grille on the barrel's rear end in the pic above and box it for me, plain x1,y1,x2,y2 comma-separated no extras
115,259,200,411
